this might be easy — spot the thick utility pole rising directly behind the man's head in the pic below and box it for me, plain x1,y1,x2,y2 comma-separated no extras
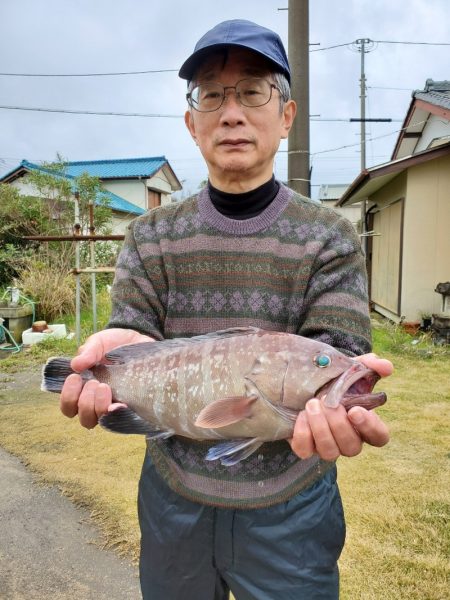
288,0,311,196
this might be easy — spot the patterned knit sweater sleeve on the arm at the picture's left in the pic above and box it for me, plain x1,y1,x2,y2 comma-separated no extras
106,223,166,340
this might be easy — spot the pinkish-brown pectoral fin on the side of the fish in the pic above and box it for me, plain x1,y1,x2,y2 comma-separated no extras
195,394,258,429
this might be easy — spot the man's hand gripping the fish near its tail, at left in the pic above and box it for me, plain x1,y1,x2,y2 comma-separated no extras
60,329,155,429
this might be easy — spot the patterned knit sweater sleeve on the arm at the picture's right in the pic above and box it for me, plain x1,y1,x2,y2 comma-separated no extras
299,218,371,356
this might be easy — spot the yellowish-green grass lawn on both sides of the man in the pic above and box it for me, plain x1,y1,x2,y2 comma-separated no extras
0,322,450,600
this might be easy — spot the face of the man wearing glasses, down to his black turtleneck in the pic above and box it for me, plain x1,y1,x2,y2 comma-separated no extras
185,49,295,193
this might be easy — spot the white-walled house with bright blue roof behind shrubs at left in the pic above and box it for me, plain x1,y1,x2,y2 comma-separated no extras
0,156,181,233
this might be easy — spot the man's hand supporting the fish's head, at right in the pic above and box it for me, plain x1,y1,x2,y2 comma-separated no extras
290,354,393,460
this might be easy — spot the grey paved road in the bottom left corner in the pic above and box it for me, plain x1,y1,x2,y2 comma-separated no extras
0,448,141,600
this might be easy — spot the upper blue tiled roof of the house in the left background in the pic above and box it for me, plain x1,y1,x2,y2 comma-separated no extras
66,156,167,179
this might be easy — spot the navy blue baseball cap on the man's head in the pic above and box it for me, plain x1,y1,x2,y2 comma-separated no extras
178,19,291,83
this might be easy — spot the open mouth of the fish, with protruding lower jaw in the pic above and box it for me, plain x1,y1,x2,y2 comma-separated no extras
316,363,387,410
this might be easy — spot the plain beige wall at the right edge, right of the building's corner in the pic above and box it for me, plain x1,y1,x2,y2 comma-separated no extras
402,156,450,321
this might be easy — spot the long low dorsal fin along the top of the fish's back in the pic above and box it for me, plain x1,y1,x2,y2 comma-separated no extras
105,327,261,364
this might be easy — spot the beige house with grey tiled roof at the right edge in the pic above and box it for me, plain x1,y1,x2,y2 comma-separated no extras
338,79,450,323
